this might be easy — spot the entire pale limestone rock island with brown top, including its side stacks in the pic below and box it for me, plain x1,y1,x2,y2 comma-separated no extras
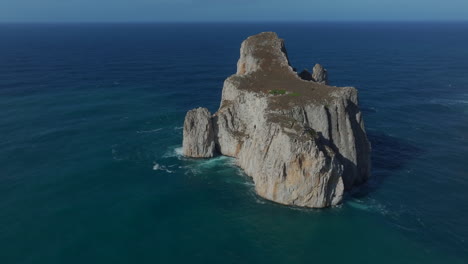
183,32,370,208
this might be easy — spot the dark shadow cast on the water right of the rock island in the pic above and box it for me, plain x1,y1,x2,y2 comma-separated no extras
351,131,424,198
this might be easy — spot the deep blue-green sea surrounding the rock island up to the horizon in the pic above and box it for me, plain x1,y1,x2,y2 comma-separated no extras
0,23,468,264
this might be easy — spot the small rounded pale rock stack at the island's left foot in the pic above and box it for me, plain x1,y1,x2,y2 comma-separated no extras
182,107,215,158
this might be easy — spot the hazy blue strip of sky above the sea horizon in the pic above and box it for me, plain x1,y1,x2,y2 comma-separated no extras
0,0,468,22
